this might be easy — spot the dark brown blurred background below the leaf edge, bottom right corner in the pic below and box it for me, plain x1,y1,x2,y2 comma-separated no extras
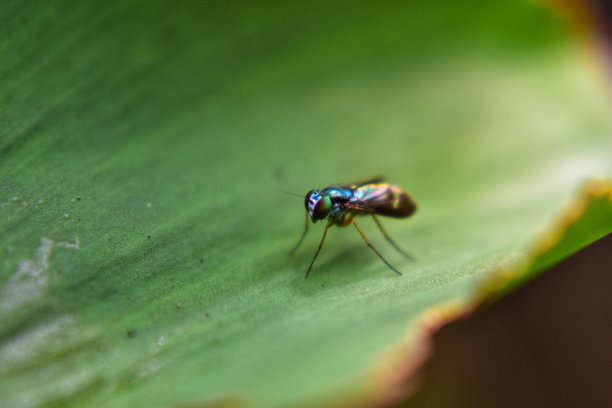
399,235,612,408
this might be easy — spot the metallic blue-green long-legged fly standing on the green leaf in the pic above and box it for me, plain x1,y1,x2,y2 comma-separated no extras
291,177,416,278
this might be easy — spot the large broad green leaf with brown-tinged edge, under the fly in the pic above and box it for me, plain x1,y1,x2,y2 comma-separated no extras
0,0,612,407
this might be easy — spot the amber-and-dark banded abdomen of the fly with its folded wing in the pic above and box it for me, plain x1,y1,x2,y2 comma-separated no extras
349,183,416,218
